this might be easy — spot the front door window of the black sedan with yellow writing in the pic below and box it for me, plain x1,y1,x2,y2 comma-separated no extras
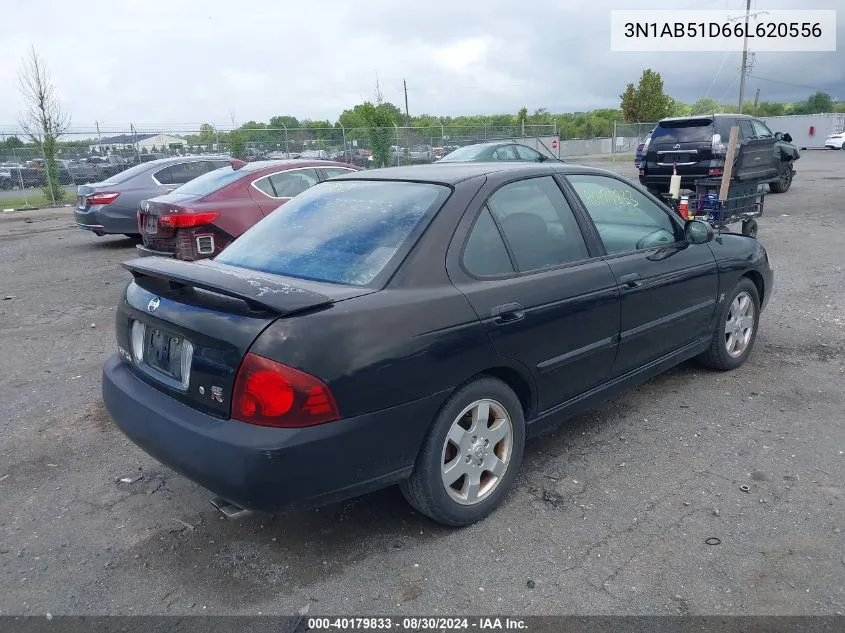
567,174,677,254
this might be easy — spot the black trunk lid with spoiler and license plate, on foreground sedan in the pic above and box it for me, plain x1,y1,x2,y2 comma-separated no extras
116,257,373,419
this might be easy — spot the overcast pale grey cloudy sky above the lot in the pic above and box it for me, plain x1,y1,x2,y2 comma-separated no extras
0,0,845,133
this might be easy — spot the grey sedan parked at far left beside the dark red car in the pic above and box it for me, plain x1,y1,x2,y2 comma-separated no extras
74,156,231,237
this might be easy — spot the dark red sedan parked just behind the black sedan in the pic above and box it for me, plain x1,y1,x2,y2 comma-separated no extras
137,160,357,260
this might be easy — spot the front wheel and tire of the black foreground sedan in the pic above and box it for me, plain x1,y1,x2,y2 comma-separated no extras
698,277,760,371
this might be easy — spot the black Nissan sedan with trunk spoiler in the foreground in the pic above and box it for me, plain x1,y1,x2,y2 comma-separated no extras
103,163,773,526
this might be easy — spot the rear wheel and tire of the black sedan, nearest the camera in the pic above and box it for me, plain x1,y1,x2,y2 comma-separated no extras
400,377,525,527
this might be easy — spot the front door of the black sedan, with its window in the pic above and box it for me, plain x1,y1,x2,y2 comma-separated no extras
567,174,719,375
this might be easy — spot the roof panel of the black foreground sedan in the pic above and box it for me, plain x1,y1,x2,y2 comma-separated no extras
336,161,618,185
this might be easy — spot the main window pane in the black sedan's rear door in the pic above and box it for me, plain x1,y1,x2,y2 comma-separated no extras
487,176,589,272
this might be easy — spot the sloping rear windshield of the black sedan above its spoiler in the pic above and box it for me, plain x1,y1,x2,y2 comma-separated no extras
216,180,450,286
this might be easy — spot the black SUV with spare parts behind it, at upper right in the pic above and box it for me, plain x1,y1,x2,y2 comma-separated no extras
640,114,799,193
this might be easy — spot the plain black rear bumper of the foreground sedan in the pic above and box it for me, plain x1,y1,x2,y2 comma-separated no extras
102,356,447,512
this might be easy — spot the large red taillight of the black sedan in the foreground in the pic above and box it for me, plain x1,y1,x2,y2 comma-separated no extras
232,353,340,427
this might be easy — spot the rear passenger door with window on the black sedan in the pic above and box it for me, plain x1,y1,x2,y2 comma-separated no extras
449,176,619,411
